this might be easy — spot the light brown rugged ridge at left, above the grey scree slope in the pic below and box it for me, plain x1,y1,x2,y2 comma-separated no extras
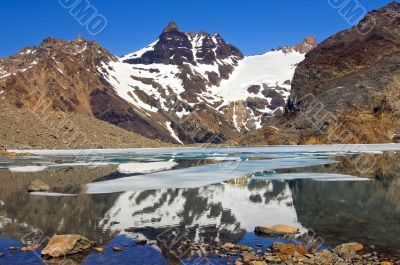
0,37,114,113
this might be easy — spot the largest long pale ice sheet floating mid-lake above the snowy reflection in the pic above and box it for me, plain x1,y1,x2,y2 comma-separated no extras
86,158,335,194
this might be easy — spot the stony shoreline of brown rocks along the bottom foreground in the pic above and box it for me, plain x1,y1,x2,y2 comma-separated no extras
0,229,400,265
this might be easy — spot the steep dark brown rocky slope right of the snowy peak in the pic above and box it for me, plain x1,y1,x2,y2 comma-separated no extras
286,2,400,143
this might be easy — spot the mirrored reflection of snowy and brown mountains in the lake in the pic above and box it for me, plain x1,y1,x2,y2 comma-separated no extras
0,146,400,264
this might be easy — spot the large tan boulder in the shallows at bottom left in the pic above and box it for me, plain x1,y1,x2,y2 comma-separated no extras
42,235,94,258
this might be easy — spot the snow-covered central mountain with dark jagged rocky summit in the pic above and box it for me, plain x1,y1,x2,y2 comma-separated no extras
94,22,315,143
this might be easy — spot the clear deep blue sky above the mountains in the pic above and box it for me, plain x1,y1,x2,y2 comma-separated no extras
0,0,390,57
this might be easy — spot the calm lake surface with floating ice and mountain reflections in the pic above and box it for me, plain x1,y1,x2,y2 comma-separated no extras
0,145,400,264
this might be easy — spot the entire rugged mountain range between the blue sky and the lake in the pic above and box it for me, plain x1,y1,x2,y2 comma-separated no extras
0,2,400,147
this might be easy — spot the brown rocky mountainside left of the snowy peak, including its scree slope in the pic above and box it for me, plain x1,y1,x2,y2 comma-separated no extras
0,37,175,144
